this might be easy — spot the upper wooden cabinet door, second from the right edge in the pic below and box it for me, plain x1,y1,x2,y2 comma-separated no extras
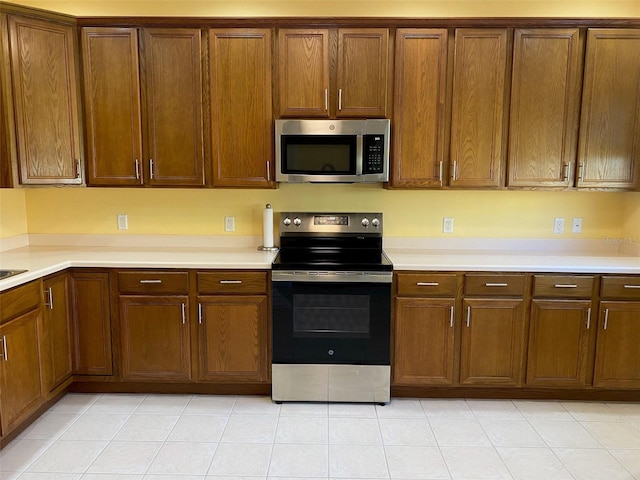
508,28,584,187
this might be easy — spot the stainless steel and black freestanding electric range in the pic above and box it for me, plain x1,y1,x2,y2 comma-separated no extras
272,212,393,403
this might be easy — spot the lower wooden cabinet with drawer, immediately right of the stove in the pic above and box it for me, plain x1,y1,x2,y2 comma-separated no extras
393,273,459,385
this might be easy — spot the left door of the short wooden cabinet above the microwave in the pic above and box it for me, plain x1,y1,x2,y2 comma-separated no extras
278,29,329,117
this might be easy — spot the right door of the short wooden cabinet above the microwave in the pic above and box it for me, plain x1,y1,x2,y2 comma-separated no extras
336,28,389,118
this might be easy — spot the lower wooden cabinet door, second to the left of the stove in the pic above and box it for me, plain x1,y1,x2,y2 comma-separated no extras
119,295,191,381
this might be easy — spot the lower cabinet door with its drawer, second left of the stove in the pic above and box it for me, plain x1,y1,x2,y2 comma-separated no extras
117,271,191,381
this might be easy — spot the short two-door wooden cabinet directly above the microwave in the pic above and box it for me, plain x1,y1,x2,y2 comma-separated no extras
278,28,389,118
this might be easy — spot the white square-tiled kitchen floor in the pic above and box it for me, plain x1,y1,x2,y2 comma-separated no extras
0,394,640,480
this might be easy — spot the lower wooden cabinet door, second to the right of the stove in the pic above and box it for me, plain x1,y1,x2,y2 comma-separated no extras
460,298,524,386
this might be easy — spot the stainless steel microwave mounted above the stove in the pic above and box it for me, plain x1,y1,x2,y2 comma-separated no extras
275,119,391,183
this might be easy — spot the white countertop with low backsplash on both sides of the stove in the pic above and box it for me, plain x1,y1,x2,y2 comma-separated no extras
0,236,640,291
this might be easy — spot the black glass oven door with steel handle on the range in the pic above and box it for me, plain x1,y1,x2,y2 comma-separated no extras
272,272,392,365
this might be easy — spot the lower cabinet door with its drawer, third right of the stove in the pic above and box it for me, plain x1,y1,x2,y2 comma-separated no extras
526,275,597,388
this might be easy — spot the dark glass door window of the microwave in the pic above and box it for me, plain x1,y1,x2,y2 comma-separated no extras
281,135,357,175
